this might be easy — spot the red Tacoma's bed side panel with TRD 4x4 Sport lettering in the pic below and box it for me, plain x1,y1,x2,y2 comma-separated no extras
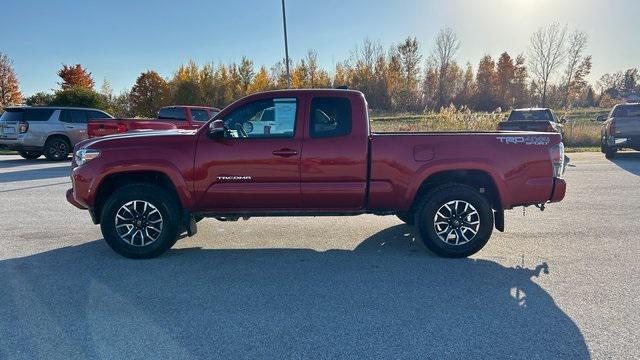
369,131,561,209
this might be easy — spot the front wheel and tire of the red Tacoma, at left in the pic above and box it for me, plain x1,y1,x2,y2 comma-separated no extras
100,184,182,259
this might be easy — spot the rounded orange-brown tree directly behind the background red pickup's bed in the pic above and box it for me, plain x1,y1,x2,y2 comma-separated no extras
129,71,169,117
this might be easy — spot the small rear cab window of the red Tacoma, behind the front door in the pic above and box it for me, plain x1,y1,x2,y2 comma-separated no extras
309,97,351,138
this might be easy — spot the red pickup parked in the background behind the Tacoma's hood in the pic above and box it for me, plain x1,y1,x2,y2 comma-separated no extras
87,106,220,138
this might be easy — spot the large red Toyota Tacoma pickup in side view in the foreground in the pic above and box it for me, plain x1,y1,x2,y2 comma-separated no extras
67,89,566,258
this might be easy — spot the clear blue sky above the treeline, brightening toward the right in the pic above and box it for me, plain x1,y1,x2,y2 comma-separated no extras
0,0,640,96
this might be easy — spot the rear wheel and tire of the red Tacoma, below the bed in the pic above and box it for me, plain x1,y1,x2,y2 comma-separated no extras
415,184,494,258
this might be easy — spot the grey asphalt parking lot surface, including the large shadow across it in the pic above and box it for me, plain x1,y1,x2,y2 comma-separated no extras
0,153,640,359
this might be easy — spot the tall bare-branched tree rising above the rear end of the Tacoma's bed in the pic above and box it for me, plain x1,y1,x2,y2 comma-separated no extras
529,23,567,106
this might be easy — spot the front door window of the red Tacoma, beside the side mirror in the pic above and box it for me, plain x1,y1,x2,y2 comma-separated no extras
222,98,298,138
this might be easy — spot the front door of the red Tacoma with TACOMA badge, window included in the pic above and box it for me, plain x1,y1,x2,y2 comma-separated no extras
193,98,302,213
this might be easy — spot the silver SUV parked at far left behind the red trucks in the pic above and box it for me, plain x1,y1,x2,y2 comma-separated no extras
0,106,113,161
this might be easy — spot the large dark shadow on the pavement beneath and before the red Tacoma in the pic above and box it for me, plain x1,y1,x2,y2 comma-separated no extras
0,225,589,359
